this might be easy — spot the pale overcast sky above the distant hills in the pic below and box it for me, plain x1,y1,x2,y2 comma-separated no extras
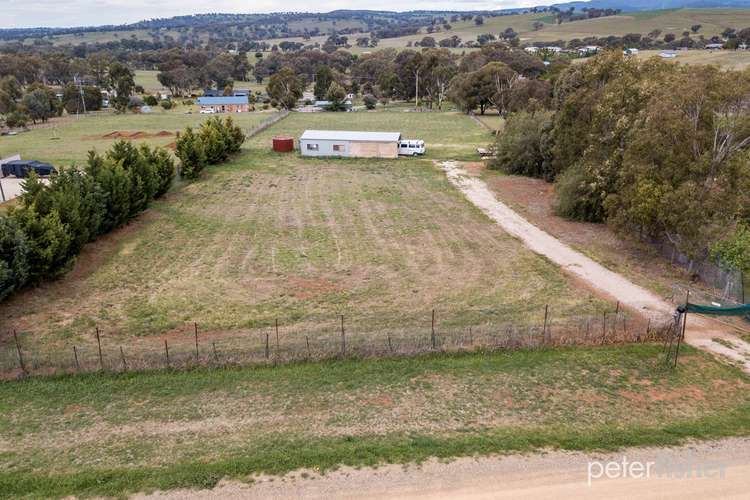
0,0,543,28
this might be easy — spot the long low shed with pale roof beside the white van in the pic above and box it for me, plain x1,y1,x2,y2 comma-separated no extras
299,130,401,158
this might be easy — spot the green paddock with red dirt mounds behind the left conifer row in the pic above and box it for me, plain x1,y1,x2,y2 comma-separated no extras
0,107,271,166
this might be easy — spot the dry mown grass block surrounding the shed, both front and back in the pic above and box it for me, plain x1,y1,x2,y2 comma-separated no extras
0,112,600,360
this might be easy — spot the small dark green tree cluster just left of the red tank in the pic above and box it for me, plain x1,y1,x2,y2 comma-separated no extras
175,116,245,179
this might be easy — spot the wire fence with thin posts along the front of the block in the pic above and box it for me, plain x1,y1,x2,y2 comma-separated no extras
0,306,674,379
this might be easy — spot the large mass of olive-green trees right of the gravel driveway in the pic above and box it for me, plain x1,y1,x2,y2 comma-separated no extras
494,51,750,265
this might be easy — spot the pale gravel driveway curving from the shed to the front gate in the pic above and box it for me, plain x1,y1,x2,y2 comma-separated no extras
439,161,750,373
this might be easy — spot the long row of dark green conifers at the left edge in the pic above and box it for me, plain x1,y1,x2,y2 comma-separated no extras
0,141,174,300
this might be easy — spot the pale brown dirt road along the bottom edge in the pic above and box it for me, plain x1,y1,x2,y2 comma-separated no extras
138,439,750,500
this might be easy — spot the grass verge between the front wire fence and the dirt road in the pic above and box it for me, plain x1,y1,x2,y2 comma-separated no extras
0,345,750,497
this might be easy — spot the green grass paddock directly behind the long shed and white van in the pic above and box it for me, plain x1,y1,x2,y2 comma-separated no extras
251,109,493,160
